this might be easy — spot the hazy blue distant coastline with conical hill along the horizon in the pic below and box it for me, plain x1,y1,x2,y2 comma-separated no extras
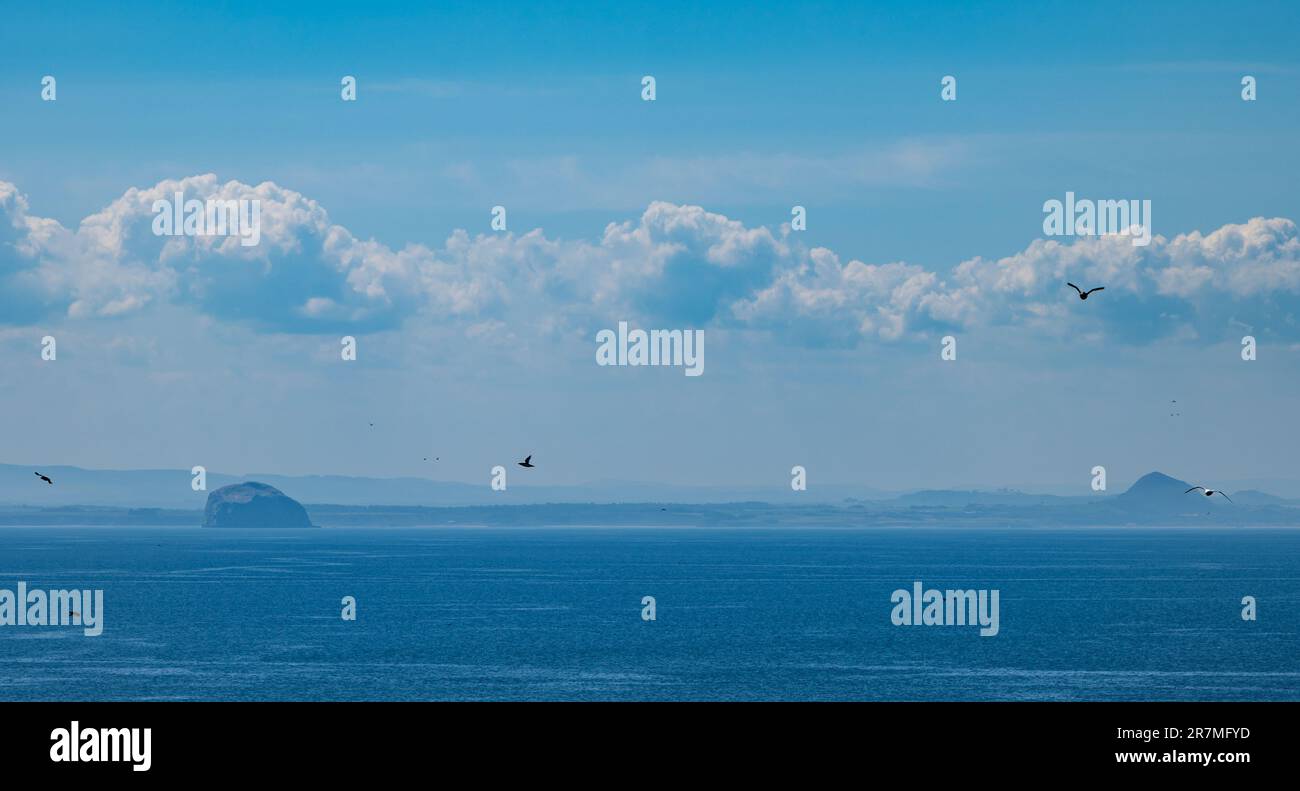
0,472,1300,528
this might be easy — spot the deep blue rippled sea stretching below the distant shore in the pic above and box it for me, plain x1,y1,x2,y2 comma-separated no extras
0,527,1300,700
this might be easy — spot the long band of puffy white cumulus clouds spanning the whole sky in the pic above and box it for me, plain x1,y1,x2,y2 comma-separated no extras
0,174,1300,345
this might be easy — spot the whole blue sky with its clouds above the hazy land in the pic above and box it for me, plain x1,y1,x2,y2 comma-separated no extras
0,3,1300,493
